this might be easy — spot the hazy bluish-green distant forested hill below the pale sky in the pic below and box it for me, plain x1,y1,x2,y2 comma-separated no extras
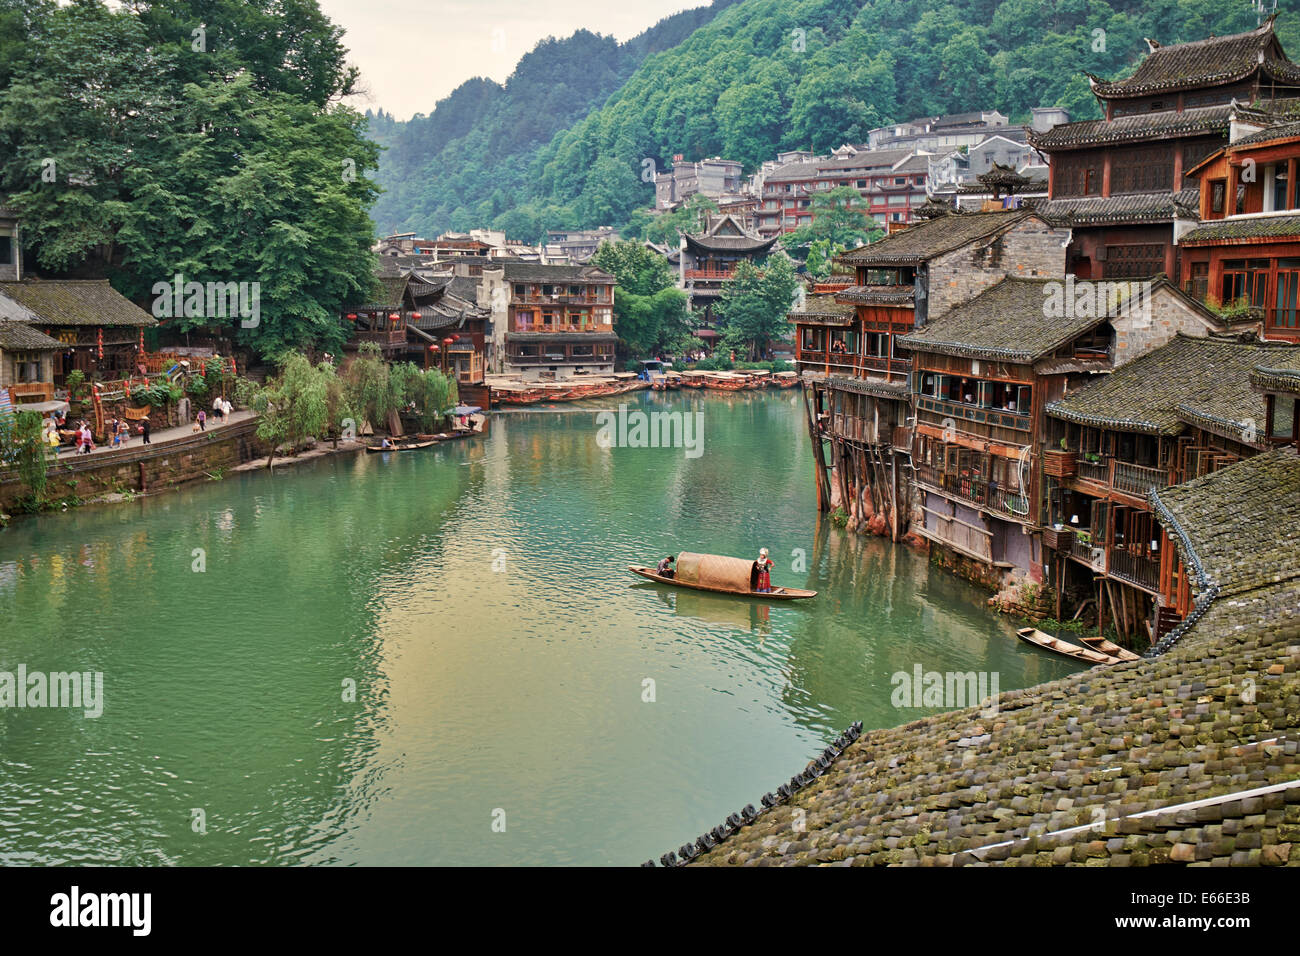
367,0,738,239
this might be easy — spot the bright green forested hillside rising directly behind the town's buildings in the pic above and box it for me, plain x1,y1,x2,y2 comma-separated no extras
376,0,1300,238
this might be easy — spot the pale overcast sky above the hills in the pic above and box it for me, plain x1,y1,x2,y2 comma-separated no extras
319,0,709,120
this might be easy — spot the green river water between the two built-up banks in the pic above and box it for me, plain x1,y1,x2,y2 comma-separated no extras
0,392,1075,865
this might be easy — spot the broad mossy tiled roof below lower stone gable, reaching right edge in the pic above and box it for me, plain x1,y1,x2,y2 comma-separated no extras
1047,333,1300,431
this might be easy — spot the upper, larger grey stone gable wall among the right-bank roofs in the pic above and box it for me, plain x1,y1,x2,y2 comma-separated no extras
927,217,1070,321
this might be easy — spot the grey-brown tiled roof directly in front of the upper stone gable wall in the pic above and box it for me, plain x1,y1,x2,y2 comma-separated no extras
898,277,1105,363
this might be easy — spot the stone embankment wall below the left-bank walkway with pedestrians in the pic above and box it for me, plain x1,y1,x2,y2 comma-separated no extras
0,419,267,511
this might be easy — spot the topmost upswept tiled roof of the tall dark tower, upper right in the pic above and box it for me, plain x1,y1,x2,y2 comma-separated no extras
1092,20,1297,99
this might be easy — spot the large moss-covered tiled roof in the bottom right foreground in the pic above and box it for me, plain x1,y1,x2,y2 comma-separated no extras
667,600,1300,866
